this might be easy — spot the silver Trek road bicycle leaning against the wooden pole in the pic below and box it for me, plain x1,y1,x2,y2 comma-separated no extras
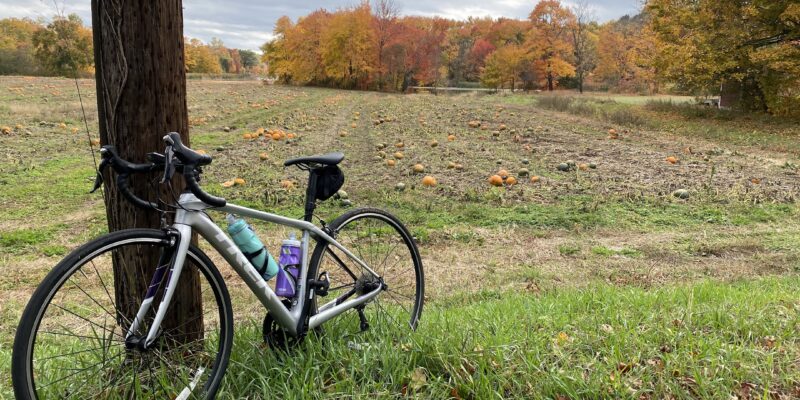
12,133,424,399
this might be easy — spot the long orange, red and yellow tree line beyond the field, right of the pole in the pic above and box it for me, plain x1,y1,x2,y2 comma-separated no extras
261,0,800,114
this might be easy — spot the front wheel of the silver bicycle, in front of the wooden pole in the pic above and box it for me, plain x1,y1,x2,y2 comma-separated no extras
12,229,233,399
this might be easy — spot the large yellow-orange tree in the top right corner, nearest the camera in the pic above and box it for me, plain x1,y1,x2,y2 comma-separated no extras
645,0,800,114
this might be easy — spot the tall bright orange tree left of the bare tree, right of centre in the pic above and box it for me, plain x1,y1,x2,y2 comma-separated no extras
529,0,575,91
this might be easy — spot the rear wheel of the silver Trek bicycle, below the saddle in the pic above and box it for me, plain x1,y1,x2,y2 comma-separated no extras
309,208,425,336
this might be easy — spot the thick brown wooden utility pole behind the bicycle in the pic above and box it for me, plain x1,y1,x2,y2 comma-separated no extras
92,0,203,338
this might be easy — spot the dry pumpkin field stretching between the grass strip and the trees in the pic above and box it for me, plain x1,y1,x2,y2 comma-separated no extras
0,74,800,324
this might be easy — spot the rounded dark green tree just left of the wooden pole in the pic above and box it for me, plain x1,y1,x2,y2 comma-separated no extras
32,14,92,76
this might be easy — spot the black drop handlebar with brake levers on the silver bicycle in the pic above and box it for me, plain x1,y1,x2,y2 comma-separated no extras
91,132,227,209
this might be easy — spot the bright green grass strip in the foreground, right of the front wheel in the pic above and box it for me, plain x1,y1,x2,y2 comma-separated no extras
208,277,800,399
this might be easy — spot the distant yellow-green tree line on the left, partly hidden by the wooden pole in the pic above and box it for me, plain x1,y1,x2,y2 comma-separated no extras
0,14,266,76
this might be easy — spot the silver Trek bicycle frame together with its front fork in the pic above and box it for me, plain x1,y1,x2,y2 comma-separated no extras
128,193,383,345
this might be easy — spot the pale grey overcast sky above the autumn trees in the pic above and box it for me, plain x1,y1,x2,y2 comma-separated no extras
0,0,641,50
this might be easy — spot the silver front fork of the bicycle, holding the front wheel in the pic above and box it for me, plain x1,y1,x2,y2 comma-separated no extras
125,225,192,350
